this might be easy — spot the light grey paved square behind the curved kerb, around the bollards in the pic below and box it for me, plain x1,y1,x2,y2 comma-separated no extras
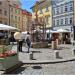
13,45,75,62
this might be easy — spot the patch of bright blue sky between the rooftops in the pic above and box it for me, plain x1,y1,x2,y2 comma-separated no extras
20,0,38,12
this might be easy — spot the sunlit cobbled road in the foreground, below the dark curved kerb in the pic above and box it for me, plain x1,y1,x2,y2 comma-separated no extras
7,61,75,75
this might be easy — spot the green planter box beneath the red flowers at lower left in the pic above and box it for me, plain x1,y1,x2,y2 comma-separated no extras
0,54,19,70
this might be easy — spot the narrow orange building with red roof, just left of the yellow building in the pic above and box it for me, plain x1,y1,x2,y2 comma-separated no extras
22,10,32,32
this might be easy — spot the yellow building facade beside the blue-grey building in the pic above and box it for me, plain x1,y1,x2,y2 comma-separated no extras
32,0,52,30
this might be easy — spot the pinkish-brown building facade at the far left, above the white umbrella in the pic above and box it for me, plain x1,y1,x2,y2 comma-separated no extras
0,0,9,25
